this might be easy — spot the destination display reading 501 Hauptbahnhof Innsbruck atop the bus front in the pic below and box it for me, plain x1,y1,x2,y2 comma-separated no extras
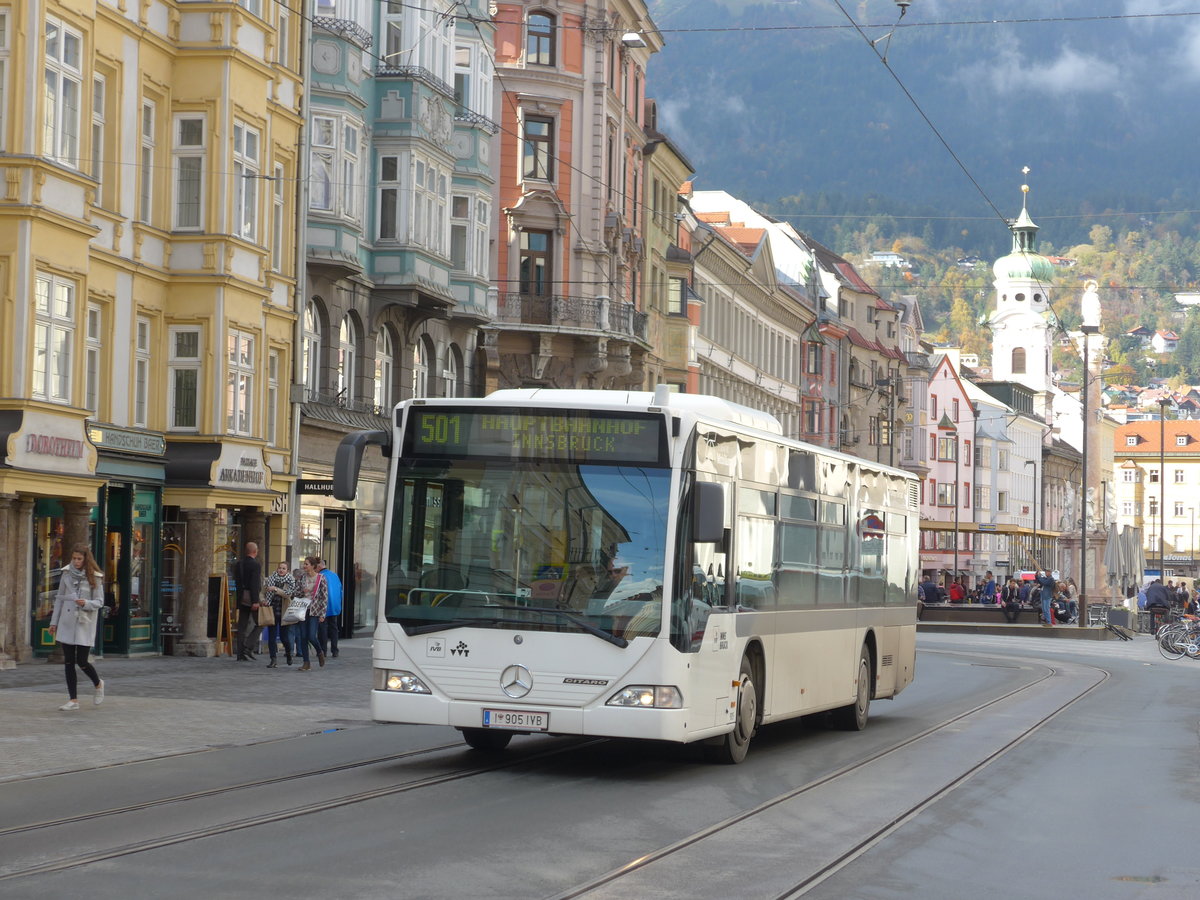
404,407,666,466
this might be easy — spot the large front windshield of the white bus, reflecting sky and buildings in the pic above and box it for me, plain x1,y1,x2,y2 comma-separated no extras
383,458,671,646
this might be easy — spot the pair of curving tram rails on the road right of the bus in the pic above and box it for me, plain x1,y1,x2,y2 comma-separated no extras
551,650,1110,900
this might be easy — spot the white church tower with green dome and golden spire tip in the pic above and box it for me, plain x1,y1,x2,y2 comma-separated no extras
988,185,1056,414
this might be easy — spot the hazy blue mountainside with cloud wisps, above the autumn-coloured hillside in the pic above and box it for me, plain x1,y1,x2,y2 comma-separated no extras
648,0,1200,251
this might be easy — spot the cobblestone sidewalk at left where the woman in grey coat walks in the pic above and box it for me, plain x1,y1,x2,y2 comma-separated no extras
0,637,371,781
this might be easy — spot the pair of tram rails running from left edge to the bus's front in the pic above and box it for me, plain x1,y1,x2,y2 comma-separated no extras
0,738,606,882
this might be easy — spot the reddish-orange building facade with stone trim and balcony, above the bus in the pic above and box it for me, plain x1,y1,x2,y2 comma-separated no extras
484,0,662,390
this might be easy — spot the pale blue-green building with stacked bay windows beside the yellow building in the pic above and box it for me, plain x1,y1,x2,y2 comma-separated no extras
294,0,499,631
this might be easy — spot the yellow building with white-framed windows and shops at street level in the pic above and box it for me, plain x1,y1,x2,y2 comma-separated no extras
0,0,302,665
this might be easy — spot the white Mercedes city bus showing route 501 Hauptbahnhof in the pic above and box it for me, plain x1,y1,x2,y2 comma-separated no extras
334,389,918,762
